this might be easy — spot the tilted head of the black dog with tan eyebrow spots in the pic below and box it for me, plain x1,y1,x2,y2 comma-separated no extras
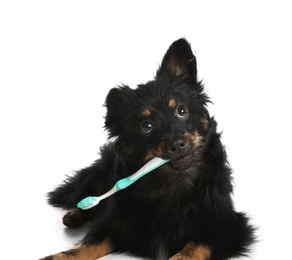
105,39,211,170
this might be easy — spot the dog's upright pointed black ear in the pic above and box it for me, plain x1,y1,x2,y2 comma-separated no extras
157,38,197,80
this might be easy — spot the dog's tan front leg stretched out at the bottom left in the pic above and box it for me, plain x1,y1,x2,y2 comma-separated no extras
40,240,113,260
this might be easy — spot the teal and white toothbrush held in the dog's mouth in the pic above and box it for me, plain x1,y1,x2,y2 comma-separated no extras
77,157,169,210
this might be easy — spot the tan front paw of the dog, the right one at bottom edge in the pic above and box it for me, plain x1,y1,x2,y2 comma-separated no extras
169,242,211,260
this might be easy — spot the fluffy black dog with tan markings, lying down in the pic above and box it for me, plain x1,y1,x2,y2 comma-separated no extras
43,39,254,260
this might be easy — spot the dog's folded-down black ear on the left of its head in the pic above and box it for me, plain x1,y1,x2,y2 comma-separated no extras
105,86,134,137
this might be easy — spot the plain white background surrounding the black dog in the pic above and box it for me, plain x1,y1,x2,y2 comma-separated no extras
0,0,292,260
